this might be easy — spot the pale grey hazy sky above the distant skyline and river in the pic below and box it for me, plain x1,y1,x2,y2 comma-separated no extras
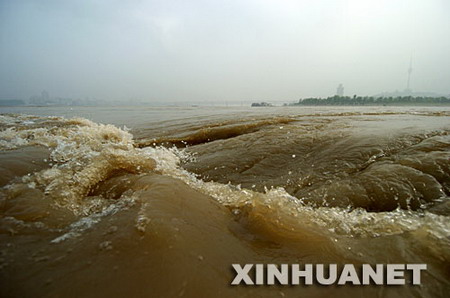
0,0,450,101
